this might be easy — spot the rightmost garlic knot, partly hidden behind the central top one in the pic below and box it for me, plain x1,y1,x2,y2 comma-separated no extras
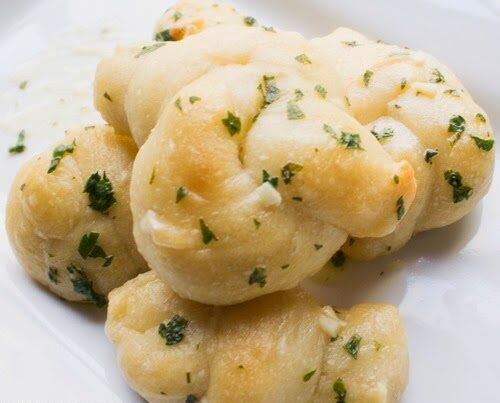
312,28,495,259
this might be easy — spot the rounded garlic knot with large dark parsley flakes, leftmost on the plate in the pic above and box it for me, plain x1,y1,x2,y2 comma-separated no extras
6,126,147,306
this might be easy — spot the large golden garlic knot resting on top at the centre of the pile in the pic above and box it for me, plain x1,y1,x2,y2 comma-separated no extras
131,61,415,305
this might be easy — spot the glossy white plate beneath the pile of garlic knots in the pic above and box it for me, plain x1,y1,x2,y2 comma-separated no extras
0,0,500,403
